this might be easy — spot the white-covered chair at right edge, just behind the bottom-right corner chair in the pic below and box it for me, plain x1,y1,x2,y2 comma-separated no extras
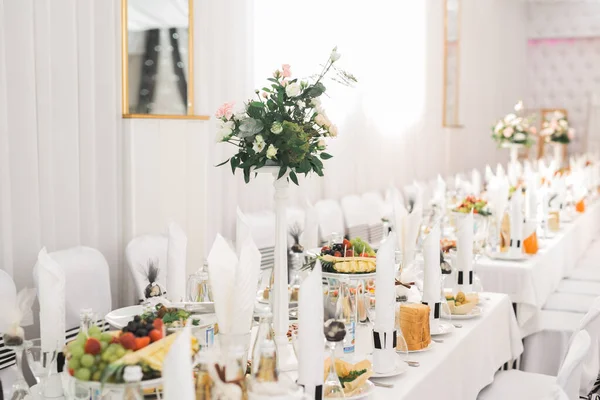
521,297,600,397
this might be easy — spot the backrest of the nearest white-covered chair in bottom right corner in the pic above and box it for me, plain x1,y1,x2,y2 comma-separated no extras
556,330,591,400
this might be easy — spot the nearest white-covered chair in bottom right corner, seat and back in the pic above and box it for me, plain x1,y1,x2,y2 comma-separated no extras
477,331,590,400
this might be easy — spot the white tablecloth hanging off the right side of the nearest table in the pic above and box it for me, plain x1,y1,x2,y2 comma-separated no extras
366,293,523,400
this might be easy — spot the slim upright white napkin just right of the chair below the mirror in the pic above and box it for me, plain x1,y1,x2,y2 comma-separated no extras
167,222,187,302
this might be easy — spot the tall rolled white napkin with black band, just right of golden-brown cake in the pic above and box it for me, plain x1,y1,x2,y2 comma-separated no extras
421,225,442,331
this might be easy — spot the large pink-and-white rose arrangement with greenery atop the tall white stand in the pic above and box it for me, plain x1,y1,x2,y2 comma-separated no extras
216,48,356,185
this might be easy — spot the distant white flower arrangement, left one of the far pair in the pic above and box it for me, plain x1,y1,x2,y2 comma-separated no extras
492,101,536,147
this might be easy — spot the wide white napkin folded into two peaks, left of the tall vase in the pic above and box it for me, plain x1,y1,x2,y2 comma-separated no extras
208,235,261,334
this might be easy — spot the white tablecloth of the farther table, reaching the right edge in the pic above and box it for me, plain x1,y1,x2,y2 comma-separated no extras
474,202,600,327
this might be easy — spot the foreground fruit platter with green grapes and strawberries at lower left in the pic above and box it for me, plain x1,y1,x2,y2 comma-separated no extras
64,318,199,388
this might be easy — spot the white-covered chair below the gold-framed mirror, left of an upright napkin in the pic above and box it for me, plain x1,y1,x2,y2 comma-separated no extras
125,234,169,301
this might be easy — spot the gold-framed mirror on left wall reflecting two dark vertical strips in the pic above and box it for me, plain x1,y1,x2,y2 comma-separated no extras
121,0,209,119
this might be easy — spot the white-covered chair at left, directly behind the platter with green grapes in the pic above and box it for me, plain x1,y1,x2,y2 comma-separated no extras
33,246,112,342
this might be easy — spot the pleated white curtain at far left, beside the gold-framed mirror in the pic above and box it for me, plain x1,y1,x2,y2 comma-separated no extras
0,0,123,305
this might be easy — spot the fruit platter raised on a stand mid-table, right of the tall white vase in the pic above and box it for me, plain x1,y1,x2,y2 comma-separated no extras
312,238,376,278
